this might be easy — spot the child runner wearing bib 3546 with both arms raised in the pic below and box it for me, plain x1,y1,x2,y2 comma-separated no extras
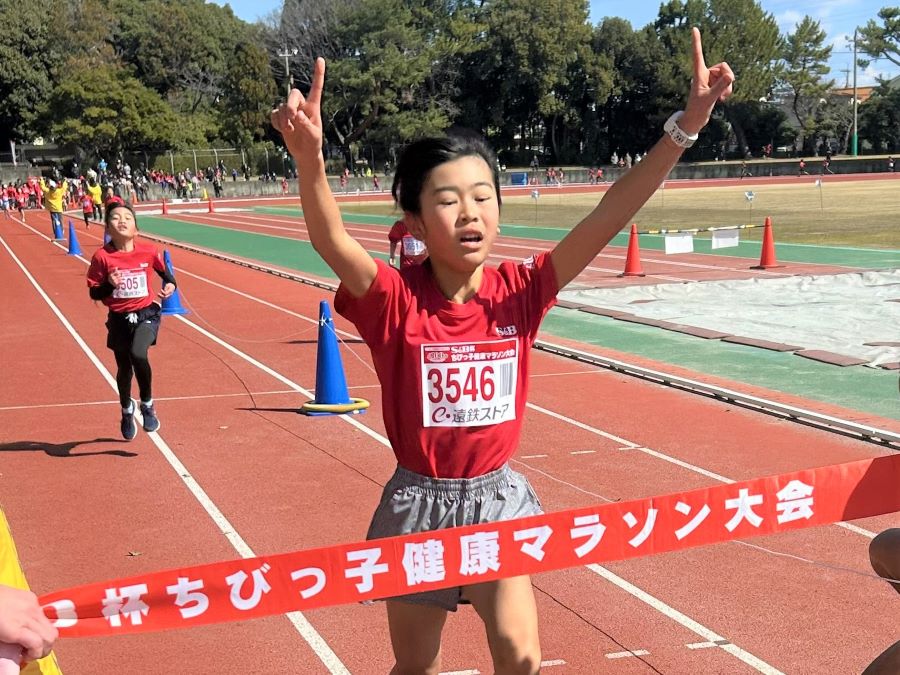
272,29,734,673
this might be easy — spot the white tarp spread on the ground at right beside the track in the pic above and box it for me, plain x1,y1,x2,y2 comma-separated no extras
559,269,900,366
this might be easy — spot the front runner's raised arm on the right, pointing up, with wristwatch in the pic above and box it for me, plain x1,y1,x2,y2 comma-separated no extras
550,28,734,289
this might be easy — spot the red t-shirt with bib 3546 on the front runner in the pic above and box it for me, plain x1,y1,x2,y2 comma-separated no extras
334,253,558,478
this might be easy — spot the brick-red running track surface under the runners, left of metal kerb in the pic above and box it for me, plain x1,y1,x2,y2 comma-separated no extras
0,214,900,675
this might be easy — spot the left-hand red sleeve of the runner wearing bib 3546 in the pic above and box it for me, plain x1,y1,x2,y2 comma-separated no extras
334,260,408,348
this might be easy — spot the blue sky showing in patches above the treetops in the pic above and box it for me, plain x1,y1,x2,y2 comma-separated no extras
213,0,900,86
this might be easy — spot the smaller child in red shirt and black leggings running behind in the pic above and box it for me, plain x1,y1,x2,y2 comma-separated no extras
87,203,175,441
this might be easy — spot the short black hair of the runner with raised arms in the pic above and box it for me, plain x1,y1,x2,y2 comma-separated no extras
391,131,500,214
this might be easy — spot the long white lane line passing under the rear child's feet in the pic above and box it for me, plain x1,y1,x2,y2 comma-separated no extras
0,226,350,675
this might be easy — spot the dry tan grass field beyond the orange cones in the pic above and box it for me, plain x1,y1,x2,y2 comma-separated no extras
341,177,900,249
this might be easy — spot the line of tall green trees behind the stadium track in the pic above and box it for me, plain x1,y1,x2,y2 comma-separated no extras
0,0,900,166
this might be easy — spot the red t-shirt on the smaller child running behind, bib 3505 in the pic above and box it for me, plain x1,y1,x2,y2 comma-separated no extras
87,240,165,313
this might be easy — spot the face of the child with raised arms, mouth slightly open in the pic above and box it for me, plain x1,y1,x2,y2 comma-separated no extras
407,156,500,272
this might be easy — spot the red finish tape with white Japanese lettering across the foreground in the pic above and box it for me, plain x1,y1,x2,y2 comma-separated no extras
40,454,900,637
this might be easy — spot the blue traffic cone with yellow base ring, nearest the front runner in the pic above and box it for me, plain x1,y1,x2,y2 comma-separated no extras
300,300,369,415
